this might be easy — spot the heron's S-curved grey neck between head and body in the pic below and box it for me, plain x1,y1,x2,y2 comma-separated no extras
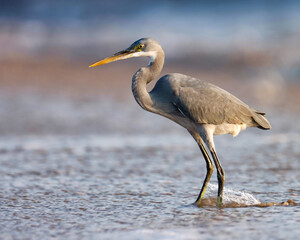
132,51,165,111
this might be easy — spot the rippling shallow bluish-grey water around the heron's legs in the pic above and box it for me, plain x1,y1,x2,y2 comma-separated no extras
0,94,300,239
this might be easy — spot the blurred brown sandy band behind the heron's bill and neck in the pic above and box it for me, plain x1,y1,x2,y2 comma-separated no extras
0,57,300,113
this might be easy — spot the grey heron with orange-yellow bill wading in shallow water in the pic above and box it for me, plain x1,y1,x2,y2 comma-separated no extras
89,38,271,207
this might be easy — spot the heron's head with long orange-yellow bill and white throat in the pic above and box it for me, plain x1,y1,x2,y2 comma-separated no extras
89,38,163,67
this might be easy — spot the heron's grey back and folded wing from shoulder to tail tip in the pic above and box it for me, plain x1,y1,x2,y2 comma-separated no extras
150,73,270,129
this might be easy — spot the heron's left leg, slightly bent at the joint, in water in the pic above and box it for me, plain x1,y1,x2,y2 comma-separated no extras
191,133,214,206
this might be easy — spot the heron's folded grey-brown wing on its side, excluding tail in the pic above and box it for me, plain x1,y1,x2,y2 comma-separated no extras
173,76,252,125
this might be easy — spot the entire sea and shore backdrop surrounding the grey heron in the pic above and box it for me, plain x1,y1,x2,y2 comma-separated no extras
0,0,300,240
